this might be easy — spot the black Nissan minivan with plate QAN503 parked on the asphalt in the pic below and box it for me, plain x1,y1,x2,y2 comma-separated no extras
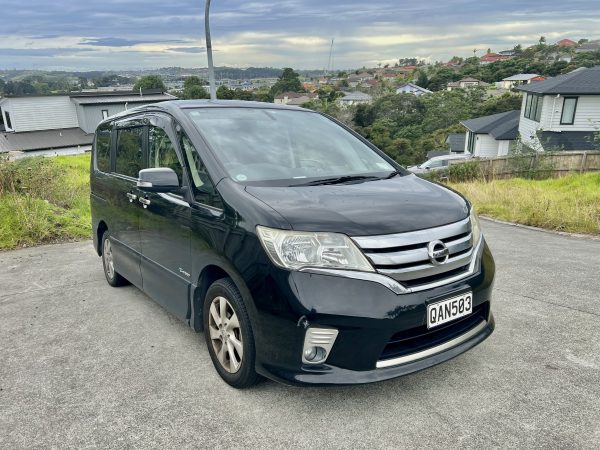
90,100,494,388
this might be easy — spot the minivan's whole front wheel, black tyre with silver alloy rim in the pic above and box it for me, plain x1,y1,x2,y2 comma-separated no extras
203,278,259,389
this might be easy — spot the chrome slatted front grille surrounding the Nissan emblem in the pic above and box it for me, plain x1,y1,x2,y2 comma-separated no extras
353,218,474,287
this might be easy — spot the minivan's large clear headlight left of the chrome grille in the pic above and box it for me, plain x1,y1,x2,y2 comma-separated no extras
256,225,375,272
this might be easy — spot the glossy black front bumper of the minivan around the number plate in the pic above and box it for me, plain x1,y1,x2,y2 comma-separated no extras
253,241,495,385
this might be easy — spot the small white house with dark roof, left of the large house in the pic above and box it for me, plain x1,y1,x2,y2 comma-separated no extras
461,110,520,157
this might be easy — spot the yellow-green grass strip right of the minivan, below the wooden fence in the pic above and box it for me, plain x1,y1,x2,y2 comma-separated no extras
451,173,600,234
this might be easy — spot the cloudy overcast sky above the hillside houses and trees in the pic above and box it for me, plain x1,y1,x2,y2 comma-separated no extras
0,0,600,70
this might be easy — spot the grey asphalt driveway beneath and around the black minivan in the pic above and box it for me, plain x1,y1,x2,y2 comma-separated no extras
0,222,600,449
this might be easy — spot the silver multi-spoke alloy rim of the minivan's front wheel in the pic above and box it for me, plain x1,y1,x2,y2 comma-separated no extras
208,296,244,373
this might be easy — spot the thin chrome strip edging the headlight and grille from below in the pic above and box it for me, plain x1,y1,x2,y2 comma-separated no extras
299,235,483,295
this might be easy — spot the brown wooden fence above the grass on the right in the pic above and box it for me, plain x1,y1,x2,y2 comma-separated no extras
449,150,600,180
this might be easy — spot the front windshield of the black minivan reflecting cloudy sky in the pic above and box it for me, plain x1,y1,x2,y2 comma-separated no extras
187,108,396,186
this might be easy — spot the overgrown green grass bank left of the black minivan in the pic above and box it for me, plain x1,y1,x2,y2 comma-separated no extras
0,154,91,249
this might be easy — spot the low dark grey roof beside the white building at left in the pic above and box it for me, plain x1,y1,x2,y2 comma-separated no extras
0,128,94,152
